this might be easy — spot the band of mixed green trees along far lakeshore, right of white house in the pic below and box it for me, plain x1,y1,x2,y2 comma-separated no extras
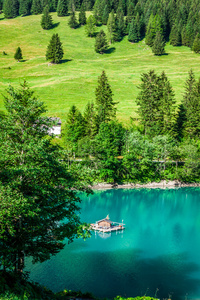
64,70,200,183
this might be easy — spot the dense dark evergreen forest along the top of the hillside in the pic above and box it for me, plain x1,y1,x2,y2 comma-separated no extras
0,0,200,51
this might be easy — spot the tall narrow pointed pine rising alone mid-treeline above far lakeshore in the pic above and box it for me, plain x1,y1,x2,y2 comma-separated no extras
95,71,117,128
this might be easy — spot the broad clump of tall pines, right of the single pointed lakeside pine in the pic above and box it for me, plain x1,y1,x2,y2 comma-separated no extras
136,70,176,136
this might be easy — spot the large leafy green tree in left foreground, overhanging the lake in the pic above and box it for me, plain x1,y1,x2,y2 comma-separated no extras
0,82,90,272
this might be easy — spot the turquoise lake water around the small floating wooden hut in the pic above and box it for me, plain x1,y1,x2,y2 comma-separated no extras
28,188,200,300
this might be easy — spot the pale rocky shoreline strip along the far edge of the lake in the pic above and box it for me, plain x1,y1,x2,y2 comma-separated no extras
90,180,200,190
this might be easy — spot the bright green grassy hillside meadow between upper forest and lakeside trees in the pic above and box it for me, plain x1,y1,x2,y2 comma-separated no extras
0,13,200,122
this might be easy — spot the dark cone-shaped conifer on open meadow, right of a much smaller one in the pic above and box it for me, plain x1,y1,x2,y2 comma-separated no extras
46,33,64,64
